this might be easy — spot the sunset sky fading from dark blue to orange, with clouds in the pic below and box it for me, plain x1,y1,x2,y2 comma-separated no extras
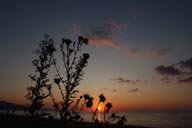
0,0,192,111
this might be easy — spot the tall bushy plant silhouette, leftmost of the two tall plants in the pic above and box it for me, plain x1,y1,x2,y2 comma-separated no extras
25,35,56,117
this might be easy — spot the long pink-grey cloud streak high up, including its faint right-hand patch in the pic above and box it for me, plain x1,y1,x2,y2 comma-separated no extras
72,21,167,58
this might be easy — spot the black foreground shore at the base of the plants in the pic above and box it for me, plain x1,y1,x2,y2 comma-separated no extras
0,114,154,128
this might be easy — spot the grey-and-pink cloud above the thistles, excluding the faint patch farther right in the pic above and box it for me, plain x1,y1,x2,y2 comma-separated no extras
83,21,140,57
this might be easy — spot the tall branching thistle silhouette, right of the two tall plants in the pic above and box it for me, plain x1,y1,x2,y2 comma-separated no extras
50,36,92,121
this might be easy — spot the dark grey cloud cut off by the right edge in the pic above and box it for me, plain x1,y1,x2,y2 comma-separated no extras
155,58,192,83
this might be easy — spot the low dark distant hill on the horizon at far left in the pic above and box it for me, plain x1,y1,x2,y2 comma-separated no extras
0,101,26,110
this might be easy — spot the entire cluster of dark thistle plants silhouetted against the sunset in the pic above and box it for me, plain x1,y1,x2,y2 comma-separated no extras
25,35,126,127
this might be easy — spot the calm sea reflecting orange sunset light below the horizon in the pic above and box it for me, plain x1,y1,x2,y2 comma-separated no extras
0,111,192,128
